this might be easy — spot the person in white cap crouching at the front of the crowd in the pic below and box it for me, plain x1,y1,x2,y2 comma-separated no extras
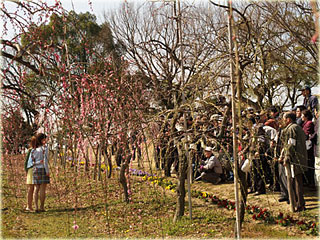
196,147,222,184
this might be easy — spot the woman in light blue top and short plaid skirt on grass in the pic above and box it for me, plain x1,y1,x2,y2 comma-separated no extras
31,133,50,212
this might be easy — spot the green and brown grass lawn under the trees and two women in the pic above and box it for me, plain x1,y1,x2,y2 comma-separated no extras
2,156,316,239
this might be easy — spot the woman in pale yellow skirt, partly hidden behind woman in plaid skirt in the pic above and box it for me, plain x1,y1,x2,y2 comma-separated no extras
24,136,36,212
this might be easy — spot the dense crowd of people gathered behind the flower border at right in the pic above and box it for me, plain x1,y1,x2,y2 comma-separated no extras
152,86,319,211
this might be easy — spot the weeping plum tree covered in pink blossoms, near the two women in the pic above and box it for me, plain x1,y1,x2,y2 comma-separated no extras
57,59,148,201
